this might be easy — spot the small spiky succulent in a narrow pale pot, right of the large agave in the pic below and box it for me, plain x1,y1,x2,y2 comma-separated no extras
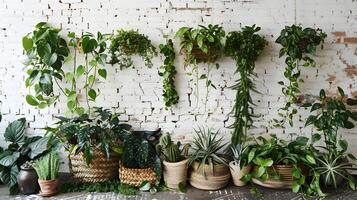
229,145,252,186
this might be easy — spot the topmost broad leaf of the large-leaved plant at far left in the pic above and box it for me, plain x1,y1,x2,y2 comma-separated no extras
4,118,26,144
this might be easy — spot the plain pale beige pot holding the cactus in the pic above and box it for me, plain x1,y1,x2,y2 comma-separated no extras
163,159,188,189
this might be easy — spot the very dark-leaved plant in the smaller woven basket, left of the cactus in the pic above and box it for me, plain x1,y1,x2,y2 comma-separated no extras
119,129,161,189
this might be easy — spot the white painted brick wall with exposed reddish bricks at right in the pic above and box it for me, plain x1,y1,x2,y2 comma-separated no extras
0,0,357,170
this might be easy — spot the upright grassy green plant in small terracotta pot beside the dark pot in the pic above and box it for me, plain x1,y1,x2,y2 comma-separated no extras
32,151,60,197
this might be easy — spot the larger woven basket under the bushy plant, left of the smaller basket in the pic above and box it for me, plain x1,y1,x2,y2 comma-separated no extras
69,149,119,183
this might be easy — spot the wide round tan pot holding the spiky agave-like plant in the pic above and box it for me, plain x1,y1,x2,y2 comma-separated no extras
189,162,231,190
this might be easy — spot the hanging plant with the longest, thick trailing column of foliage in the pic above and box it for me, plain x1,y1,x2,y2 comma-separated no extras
224,25,268,147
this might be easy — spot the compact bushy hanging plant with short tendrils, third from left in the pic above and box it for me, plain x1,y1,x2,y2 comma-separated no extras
109,29,157,69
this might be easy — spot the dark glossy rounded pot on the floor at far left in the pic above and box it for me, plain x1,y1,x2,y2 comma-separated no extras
17,164,40,195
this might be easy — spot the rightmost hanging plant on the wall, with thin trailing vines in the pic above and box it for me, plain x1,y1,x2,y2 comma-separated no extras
274,25,327,127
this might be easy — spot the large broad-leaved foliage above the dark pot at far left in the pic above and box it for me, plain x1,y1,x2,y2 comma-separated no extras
0,118,52,194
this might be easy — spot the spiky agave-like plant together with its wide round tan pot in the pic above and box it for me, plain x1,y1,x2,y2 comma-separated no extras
188,128,231,190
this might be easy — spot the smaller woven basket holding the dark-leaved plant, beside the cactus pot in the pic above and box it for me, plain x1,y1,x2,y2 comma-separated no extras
119,163,159,187
